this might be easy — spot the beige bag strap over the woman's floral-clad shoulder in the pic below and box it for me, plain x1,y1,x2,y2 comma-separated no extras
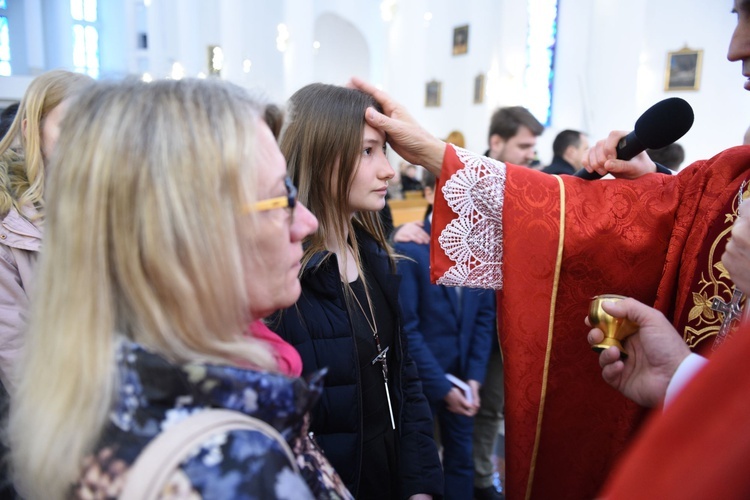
119,409,299,500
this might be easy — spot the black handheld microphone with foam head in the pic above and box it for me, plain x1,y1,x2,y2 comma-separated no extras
574,97,695,180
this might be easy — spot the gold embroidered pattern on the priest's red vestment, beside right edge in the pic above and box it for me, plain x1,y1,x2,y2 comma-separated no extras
682,186,750,349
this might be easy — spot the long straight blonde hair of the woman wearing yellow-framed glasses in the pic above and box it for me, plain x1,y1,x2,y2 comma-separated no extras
9,80,276,498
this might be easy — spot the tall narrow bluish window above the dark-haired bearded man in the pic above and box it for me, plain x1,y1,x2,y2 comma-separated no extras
524,0,558,126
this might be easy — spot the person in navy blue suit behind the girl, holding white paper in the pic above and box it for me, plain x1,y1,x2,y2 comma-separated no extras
395,173,497,499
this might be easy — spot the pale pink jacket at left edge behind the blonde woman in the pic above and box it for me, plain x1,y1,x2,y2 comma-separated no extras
0,208,42,394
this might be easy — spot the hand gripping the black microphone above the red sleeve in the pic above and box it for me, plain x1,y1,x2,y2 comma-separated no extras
582,130,656,179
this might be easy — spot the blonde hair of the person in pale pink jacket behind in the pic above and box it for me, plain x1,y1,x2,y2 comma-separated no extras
0,70,93,214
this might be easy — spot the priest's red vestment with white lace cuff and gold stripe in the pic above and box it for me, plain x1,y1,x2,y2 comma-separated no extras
431,145,750,499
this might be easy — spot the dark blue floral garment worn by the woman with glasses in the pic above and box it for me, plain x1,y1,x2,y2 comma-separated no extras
72,340,352,500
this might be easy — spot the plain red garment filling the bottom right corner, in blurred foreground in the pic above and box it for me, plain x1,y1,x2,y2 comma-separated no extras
602,324,750,500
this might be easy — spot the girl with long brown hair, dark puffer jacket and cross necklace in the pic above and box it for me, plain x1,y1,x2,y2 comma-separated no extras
270,84,443,499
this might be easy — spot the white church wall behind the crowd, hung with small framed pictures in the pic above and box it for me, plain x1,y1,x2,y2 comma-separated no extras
0,0,750,170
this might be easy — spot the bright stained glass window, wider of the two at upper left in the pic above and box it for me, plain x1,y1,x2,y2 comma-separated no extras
70,0,99,78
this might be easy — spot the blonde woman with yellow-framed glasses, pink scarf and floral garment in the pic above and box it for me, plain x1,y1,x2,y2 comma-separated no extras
9,80,356,499
